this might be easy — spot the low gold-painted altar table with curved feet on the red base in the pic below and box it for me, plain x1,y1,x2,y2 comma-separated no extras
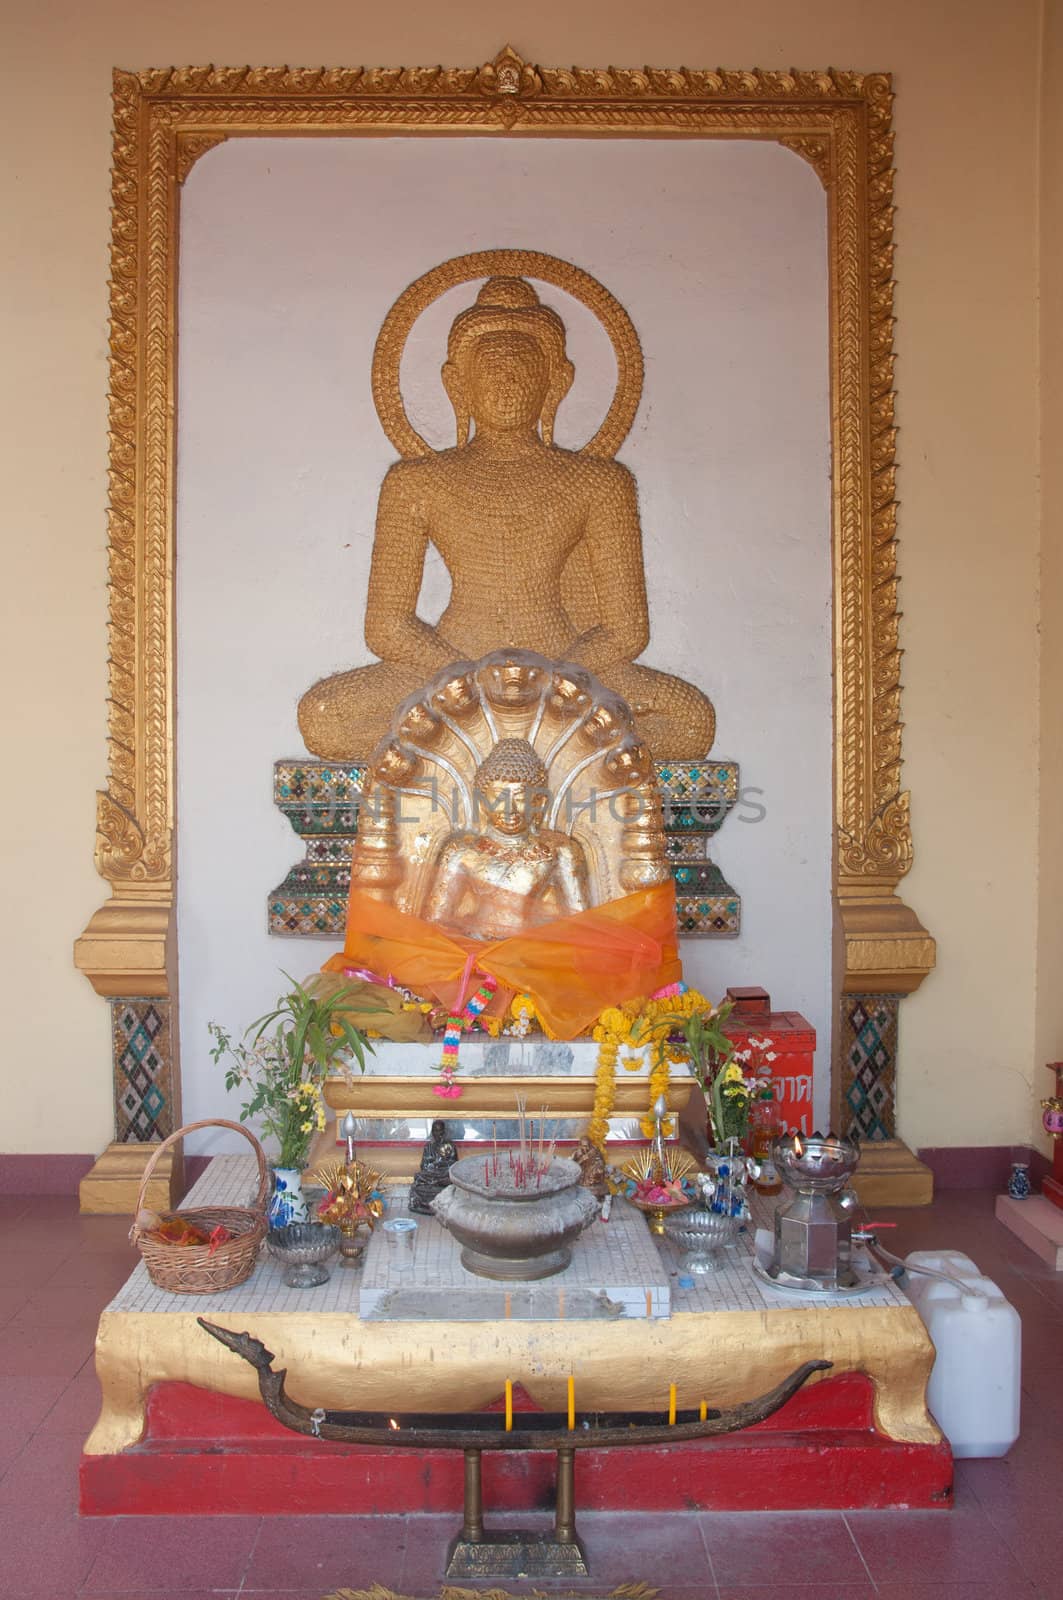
85,1157,941,1456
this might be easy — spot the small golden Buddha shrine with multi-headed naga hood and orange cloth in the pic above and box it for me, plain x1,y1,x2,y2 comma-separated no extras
325,650,680,1036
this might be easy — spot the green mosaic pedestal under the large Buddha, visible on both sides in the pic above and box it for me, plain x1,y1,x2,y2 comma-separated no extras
267,758,741,939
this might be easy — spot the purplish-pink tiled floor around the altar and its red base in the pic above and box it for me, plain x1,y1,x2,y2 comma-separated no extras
0,1190,1063,1600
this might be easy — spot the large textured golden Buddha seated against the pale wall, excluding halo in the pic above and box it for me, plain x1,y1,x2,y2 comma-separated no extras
299,277,716,760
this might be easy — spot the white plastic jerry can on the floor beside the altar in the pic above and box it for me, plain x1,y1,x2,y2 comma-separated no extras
905,1250,1023,1456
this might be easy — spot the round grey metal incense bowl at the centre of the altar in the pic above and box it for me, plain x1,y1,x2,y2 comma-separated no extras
432,1155,599,1283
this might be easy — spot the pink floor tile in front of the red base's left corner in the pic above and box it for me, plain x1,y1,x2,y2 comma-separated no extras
85,1517,259,1595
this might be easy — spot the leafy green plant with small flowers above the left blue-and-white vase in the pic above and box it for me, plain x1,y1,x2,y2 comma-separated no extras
208,973,373,1170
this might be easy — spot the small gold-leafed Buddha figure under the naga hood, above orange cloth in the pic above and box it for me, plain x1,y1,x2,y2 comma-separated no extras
426,739,591,939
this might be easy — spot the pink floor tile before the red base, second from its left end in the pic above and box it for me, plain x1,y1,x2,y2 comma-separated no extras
245,1517,408,1595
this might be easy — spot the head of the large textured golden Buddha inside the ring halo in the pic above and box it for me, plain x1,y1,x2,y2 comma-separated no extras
442,278,575,448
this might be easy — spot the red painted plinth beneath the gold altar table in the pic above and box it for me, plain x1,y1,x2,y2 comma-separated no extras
80,1373,953,1517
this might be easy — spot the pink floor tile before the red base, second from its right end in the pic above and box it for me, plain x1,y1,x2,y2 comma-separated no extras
700,1512,869,1589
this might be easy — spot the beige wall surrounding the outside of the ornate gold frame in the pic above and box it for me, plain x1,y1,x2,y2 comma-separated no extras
0,0,1043,1150
